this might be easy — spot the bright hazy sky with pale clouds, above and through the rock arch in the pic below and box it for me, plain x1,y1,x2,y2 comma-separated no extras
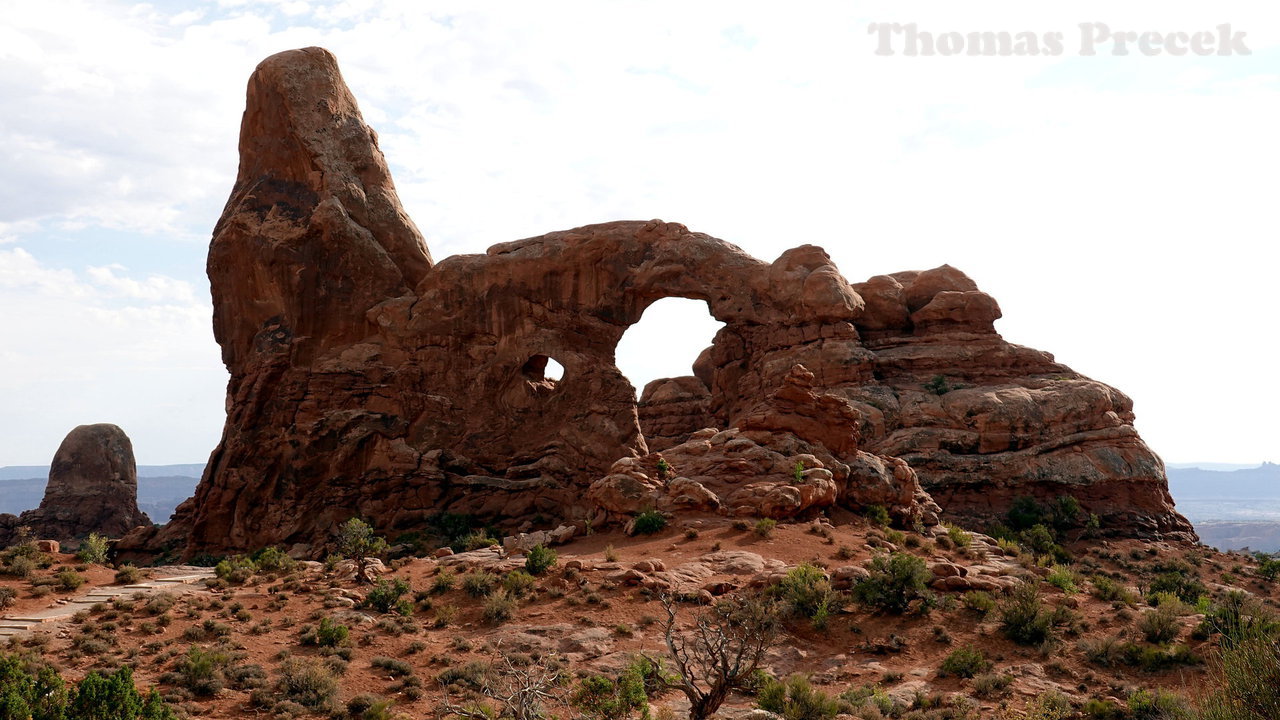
0,0,1280,465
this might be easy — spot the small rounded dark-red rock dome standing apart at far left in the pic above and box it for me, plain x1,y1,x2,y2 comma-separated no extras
0,423,151,544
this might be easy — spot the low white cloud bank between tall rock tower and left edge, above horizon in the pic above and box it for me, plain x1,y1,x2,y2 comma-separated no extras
0,247,227,465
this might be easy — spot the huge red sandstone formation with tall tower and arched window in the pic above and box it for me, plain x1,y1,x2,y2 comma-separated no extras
137,47,1190,555
